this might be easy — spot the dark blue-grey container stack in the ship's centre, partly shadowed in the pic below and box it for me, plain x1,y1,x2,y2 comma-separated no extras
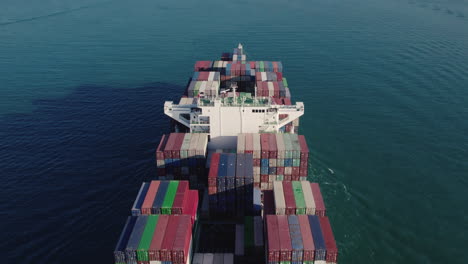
208,153,254,216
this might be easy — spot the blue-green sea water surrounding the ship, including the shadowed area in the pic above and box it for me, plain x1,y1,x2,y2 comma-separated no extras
0,0,468,264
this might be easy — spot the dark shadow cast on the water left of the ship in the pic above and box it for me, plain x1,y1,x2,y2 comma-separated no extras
0,83,183,263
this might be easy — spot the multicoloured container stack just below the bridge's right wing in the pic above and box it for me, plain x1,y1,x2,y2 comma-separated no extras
237,133,309,190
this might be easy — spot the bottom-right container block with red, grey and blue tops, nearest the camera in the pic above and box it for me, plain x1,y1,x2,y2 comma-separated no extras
265,215,338,264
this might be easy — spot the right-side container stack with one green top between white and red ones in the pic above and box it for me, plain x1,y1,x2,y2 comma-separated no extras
273,181,326,217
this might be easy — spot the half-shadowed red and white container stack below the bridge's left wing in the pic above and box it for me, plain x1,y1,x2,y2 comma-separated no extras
156,133,208,186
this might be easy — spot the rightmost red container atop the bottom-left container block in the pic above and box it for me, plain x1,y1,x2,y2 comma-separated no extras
172,215,192,264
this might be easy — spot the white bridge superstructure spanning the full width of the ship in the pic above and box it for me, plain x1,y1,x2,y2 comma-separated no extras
164,44,304,149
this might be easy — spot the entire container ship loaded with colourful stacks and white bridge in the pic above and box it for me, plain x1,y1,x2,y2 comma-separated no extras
114,44,338,264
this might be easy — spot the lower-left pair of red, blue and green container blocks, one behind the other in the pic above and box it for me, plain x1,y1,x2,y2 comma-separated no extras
114,181,198,264
